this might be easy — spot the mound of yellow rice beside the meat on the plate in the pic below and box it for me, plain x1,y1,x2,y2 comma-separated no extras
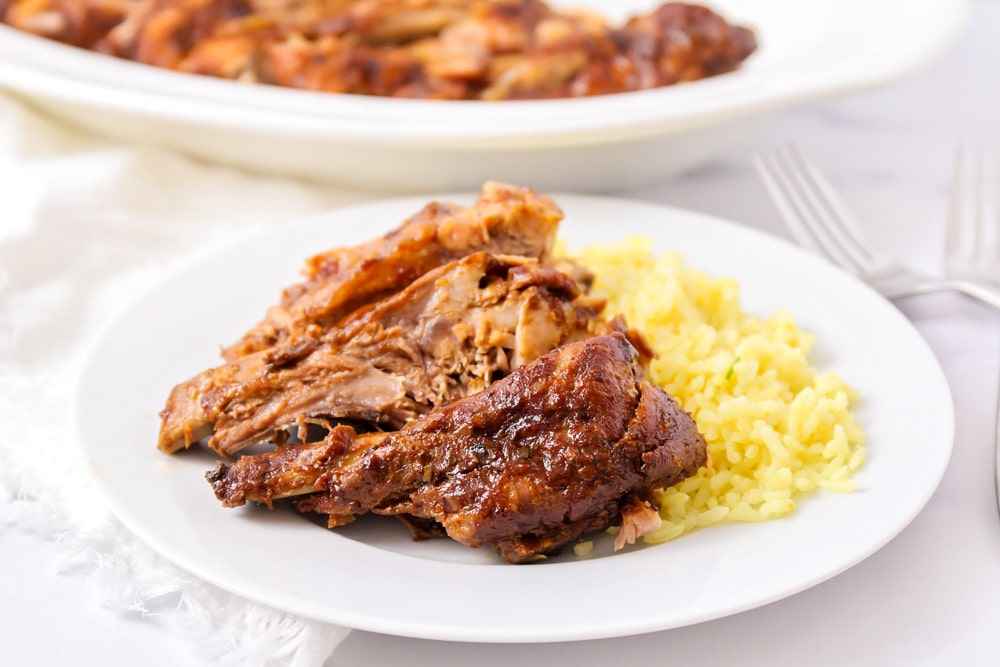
578,237,865,543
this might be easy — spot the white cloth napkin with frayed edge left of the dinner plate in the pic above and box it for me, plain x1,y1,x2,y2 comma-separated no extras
0,95,378,667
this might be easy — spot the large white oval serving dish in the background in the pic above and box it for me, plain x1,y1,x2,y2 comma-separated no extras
0,0,967,191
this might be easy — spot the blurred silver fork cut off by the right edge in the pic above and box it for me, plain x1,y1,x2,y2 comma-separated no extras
944,147,1000,511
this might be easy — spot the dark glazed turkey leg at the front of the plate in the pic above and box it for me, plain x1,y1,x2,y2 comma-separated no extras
208,333,707,562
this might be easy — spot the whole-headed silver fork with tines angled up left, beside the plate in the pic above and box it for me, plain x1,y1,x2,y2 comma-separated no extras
754,146,1000,309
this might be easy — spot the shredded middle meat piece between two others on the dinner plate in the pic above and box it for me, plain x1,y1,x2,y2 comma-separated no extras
159,253,603,456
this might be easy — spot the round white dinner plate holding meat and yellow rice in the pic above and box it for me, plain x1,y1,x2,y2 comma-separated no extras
76,196,953,642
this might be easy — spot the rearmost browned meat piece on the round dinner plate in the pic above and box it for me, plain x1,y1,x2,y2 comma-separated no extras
223,183,562,361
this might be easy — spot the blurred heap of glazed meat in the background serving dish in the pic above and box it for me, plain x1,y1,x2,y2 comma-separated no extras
0,0,756,100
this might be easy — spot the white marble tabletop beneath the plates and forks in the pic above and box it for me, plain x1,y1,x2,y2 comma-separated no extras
0,0,1000,667
